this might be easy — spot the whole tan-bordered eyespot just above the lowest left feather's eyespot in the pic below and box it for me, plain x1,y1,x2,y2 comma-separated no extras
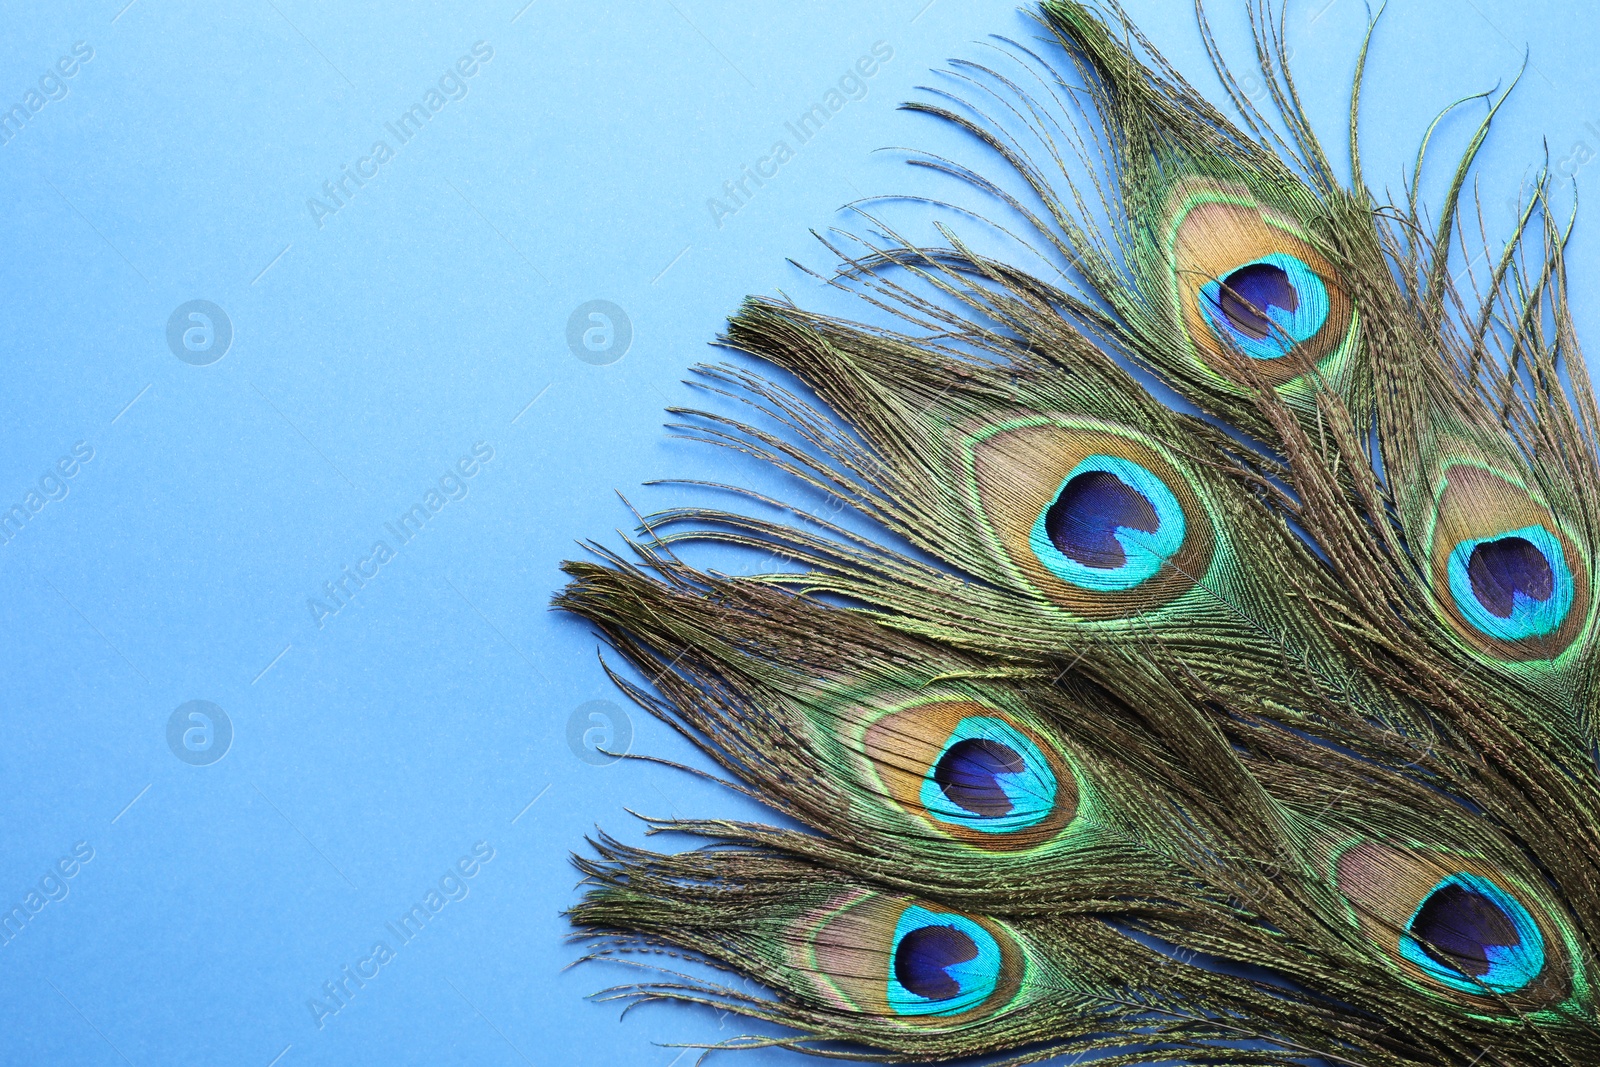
862,701,1078,851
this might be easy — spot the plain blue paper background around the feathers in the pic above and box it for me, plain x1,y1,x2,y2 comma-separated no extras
0,0,1600,1067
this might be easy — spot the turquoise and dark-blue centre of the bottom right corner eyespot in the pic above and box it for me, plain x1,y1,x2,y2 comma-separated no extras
1400,872,1544,993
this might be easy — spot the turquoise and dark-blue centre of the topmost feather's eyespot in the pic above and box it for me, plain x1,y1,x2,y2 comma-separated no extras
1200,253,1328,360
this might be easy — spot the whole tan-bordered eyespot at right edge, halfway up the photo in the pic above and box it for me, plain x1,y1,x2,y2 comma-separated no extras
1430,462,1590,661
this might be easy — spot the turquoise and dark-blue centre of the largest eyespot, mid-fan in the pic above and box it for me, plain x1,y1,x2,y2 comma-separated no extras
1029,456,1186,593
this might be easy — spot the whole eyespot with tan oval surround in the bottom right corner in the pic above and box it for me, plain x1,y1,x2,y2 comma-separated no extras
1334,841,1574,1009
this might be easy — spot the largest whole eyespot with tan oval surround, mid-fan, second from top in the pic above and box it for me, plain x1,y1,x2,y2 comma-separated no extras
970,416,1216,619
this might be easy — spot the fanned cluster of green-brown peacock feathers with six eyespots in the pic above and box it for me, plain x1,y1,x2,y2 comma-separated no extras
557,2,1600,1067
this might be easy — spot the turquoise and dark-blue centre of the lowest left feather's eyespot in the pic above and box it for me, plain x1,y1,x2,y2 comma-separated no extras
886,904,1002,1016
